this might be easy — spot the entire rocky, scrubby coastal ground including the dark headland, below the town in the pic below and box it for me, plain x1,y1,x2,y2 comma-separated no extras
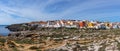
0,23,120,51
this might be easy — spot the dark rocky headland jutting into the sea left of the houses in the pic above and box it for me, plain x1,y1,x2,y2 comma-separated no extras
6,23,37,32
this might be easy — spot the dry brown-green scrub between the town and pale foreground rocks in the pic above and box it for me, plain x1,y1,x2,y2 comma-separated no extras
0,29,120,51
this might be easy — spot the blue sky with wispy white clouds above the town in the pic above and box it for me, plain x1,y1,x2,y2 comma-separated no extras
0,0,120,25
